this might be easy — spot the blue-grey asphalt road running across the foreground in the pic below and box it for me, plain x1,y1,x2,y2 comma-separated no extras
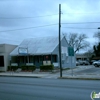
0,77,100,100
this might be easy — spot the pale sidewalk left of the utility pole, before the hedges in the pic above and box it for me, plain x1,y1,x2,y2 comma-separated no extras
0,69,59,78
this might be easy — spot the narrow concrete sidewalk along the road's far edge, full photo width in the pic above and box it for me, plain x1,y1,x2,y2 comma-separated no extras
0,73,100,80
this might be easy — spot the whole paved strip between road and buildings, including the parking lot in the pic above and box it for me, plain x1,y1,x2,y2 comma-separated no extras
0,65,100,80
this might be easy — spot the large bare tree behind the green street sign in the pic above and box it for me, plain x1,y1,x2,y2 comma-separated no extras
64,33,90,53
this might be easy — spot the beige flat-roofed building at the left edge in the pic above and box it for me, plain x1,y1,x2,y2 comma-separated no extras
0,44,17,71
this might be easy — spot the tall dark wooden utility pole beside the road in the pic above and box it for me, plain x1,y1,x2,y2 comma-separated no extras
59,4,62,77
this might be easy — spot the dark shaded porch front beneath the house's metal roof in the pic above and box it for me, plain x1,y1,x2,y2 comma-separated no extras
11,54,57,67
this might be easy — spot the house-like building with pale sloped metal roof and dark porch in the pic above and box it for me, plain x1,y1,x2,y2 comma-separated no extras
10,37,76,68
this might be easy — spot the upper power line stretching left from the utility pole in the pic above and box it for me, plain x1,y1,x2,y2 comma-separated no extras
0,14,58,19
